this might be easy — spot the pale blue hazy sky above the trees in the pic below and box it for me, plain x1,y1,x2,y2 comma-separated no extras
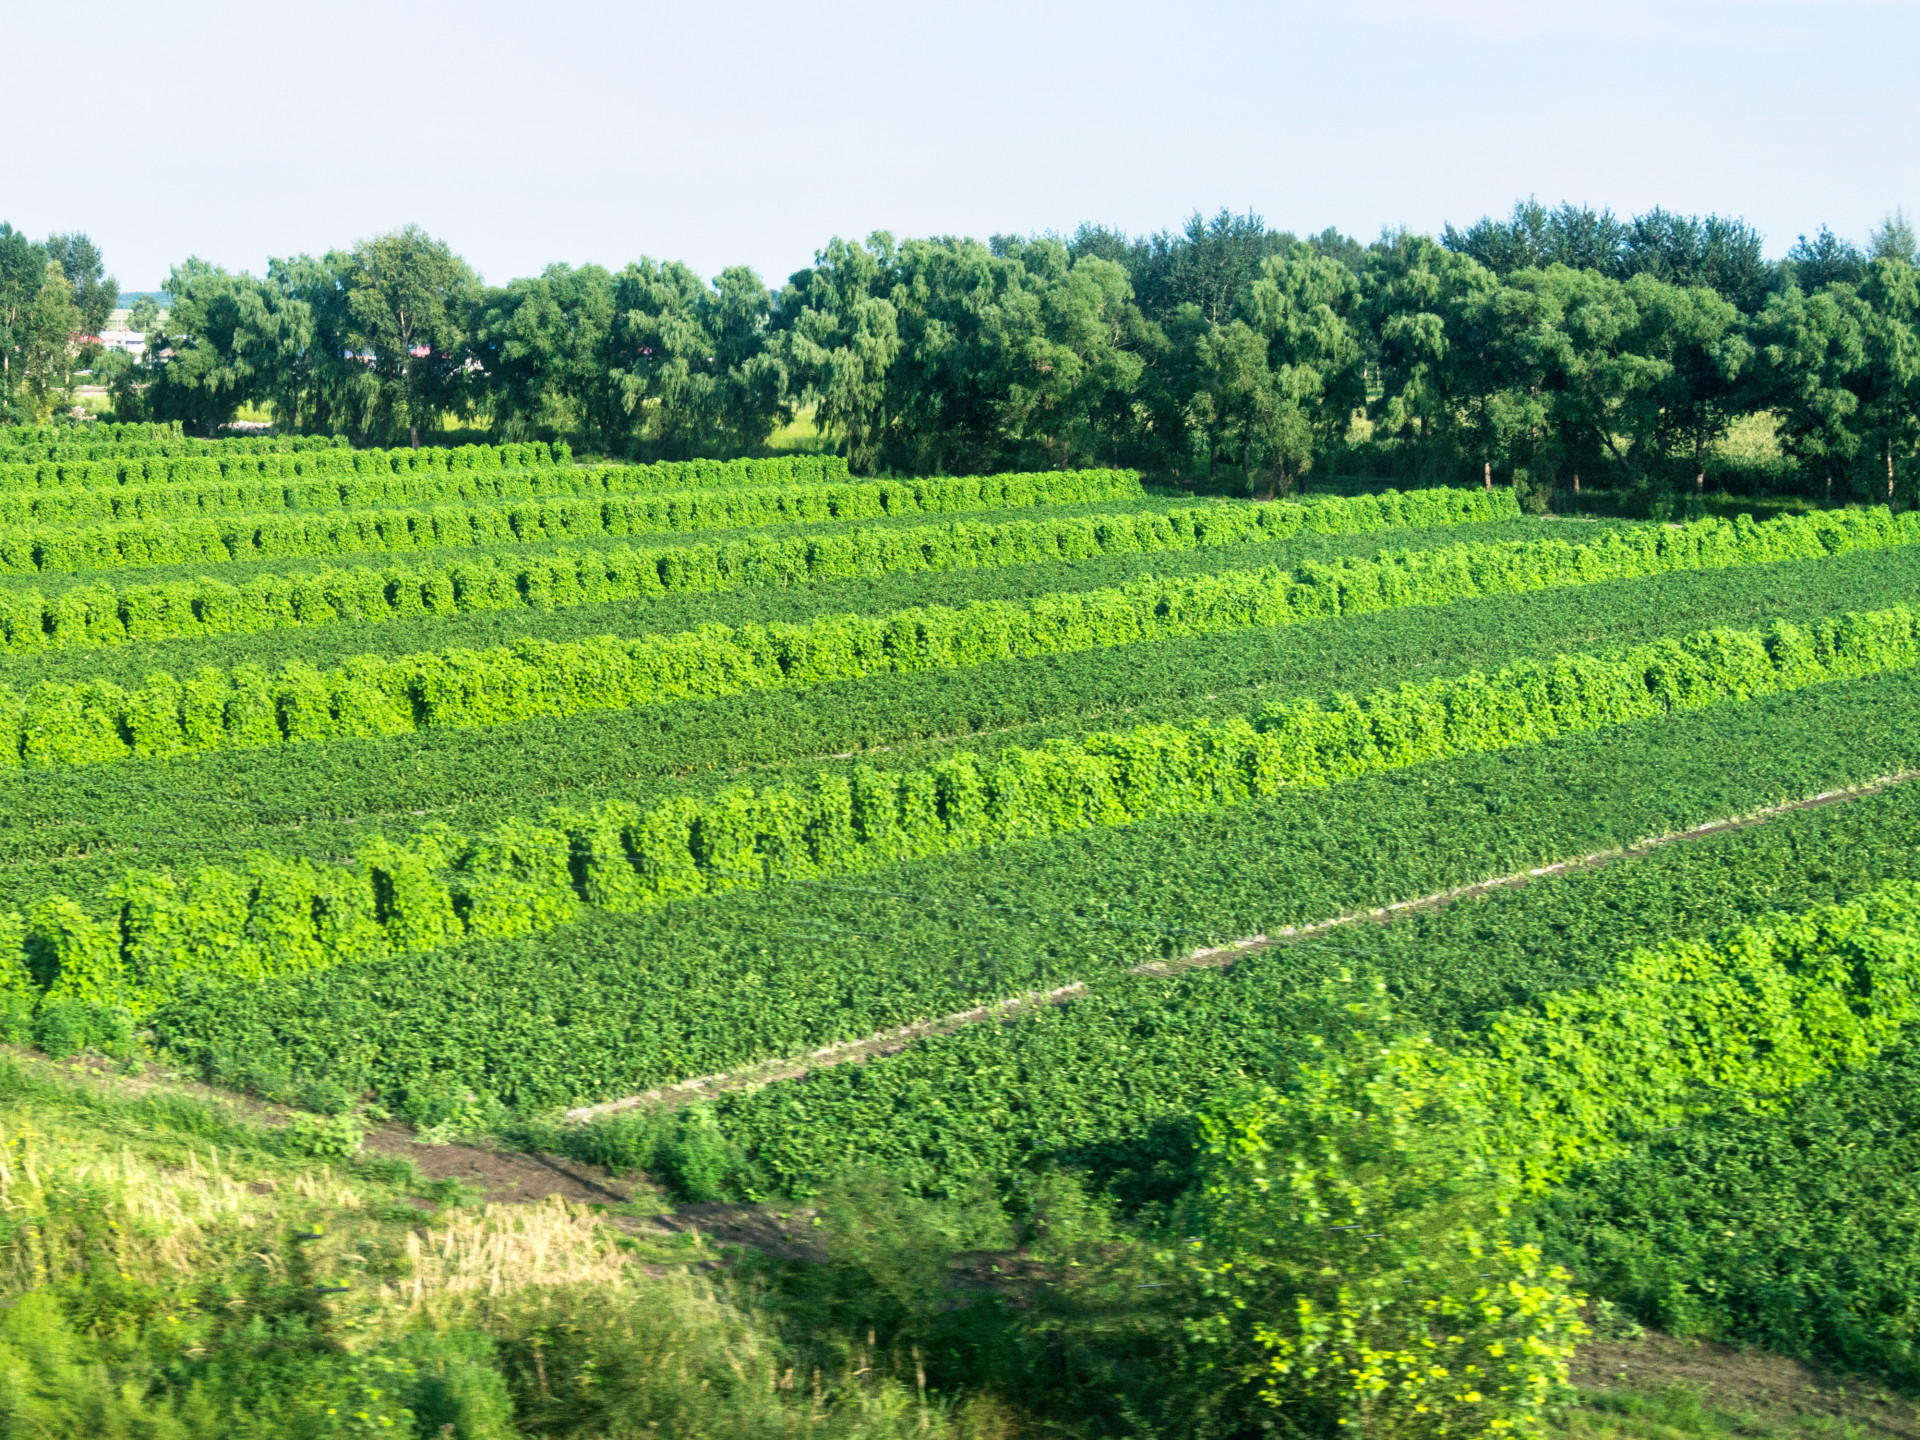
0,0,1920,290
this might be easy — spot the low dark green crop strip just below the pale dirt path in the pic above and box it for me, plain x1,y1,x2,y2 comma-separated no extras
683,785,1920,1200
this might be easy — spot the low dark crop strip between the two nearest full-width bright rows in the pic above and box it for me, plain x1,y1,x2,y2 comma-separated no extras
11,549,1920,925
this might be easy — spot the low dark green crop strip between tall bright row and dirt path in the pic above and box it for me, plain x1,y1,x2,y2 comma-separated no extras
152,652,1916,1113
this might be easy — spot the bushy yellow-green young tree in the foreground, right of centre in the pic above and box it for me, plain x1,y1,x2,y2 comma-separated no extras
1177,1004,1586,1438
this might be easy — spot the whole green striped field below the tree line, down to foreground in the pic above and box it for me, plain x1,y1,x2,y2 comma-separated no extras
11,422,1920,1436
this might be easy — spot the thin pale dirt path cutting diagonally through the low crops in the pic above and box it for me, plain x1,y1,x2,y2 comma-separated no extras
566,770,1920,1123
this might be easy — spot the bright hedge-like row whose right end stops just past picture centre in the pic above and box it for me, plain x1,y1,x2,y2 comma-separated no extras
0,470,1142,574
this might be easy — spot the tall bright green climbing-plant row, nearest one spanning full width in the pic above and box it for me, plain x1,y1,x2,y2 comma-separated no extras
15,607,1920,1021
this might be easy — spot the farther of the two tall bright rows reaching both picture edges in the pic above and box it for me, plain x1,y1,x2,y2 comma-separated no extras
0,511,1920,768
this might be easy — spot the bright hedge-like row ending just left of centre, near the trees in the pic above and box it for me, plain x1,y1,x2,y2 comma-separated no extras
0,457,864,524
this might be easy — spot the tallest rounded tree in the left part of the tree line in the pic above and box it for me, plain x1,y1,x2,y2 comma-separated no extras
346,225,478,447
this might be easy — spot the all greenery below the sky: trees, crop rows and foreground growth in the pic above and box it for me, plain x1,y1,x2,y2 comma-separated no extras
0,204,1920,1440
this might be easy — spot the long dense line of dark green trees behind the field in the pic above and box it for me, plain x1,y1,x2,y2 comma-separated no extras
6,202,1920,499
